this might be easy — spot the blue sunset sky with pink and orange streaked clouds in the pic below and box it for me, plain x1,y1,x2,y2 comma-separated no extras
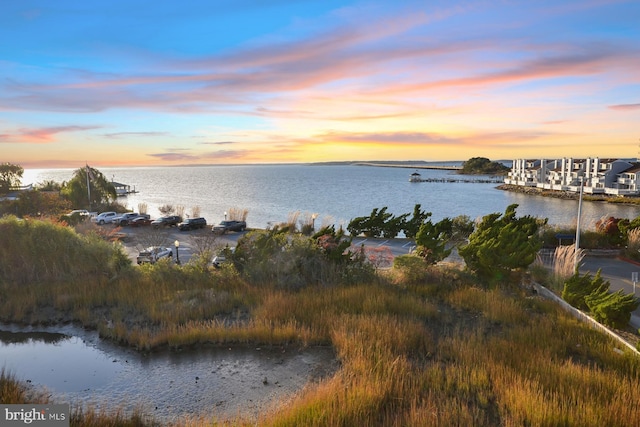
0,0,640,168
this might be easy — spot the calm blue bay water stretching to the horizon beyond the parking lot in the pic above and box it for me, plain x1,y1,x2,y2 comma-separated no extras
23,165,640,228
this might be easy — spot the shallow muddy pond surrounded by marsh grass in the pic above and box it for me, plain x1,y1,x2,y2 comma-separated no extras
0,330,335,421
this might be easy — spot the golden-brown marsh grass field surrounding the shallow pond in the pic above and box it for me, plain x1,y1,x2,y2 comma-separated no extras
0,220,640,426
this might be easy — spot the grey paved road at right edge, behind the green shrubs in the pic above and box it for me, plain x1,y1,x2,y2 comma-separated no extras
579,257,640,328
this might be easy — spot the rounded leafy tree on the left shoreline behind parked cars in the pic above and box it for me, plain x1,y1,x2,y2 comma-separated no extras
60,166,117,210
